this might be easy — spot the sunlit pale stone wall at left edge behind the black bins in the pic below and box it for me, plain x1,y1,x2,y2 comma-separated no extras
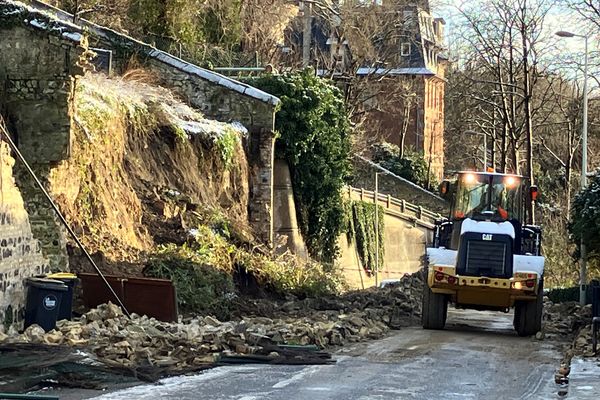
0,142,49,331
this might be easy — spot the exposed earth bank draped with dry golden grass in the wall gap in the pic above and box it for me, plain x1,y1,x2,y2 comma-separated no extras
48,73,248,268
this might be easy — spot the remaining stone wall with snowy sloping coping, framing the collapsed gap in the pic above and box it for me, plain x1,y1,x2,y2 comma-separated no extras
0,1,278,276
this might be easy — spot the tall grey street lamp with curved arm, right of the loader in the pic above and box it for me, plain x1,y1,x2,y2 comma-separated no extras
556,31,588,305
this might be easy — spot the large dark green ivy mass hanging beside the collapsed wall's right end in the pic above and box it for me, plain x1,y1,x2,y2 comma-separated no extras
249,70,350,264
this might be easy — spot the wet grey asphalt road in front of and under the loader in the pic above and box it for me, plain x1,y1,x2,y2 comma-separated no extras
50,310,560,400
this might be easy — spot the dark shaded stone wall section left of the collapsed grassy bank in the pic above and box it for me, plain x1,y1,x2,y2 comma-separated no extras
0,25,85,270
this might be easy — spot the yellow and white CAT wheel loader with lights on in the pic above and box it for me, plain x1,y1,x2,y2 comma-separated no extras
422,171,544,336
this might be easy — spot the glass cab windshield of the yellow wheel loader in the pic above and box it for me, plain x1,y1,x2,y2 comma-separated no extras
452,172,523,221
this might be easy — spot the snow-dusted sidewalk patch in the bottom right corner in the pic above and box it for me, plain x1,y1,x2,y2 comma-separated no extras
568,357,600,400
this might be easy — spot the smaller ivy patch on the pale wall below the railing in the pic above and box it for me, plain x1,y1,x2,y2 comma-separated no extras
346,201,385,273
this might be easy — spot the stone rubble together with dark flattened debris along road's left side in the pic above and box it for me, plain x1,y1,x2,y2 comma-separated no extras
0,273,422,391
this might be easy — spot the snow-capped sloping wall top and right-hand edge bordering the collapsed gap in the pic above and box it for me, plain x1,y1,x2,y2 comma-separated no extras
0,0,279,244
